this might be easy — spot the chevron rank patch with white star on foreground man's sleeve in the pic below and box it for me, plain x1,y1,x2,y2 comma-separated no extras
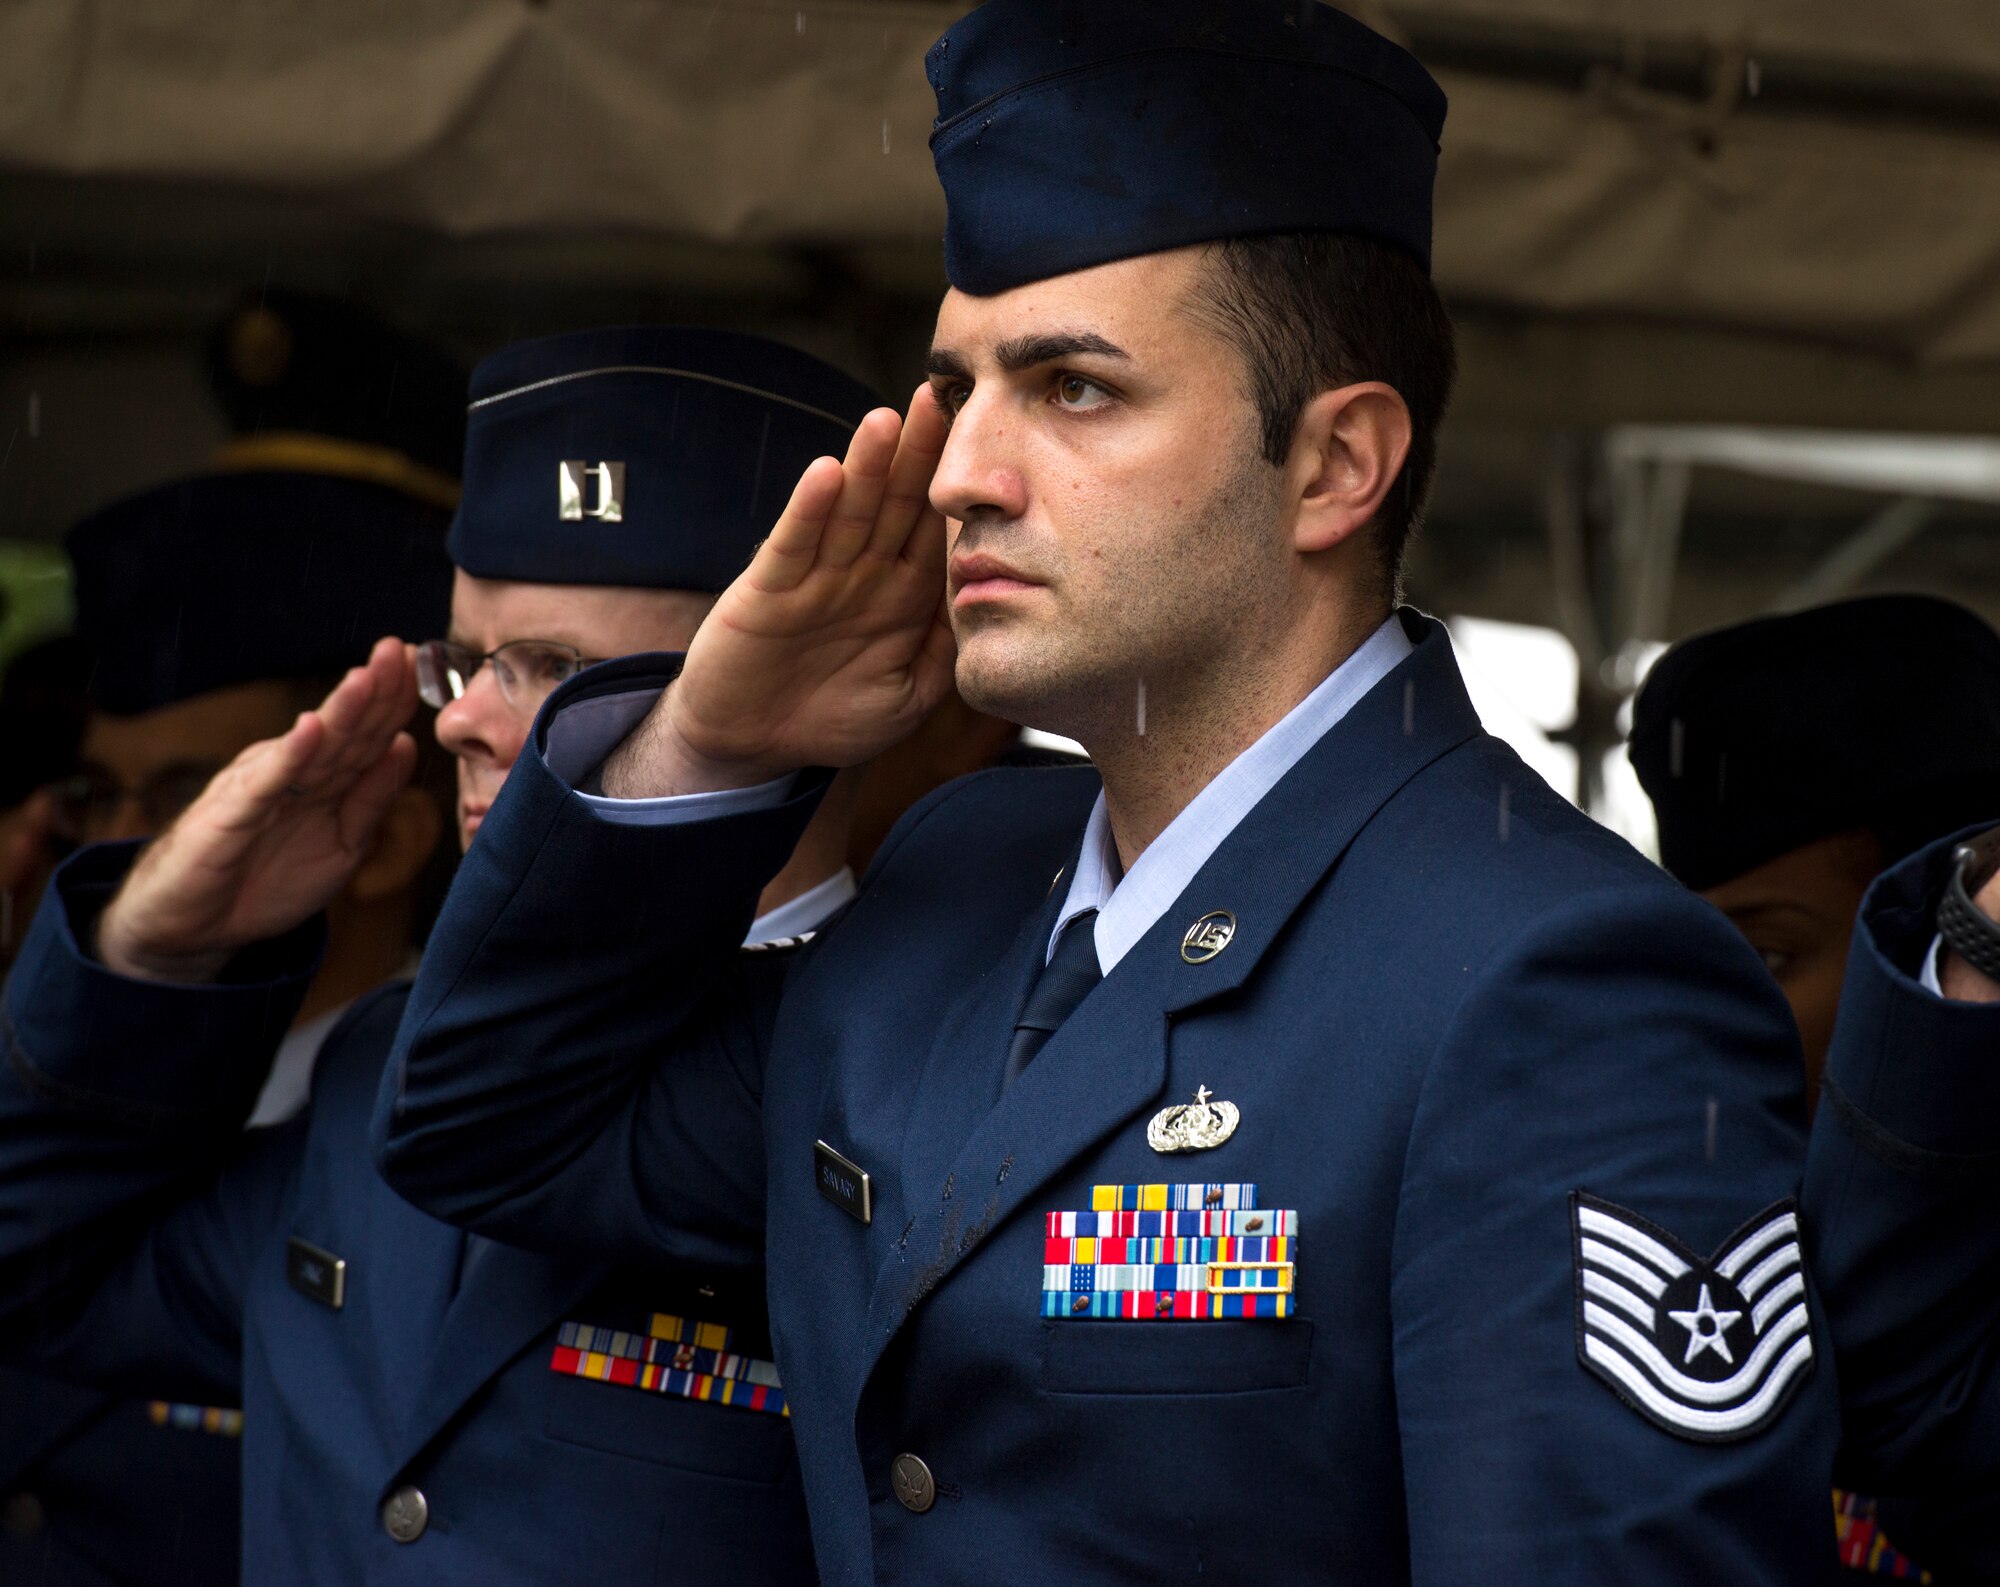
1570,1191,1814,1443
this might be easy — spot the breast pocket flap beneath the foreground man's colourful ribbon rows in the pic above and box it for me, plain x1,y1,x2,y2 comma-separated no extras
1042,1317,1312,1395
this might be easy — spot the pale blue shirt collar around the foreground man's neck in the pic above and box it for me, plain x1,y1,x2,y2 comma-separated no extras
1048,614,1412,975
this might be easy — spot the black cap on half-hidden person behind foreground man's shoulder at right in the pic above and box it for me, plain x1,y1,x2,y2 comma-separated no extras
1630,596,2000,889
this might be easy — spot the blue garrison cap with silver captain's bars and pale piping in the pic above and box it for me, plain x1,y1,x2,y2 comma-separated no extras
464,326,880,590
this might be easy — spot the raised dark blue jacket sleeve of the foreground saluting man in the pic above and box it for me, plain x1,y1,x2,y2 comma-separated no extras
374,658,828,1263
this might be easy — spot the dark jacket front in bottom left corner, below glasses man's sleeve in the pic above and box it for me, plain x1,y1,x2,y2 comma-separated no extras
0,1367,240,1587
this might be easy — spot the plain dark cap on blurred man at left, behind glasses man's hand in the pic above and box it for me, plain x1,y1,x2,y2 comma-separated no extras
66,470,452,716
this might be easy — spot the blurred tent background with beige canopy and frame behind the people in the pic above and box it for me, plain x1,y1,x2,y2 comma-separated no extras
0,0,2000,841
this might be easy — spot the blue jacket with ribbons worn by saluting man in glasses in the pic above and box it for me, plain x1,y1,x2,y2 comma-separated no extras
0,849,814,1587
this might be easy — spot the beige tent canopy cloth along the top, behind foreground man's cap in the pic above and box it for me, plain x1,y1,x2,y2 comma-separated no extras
0,0,2000,366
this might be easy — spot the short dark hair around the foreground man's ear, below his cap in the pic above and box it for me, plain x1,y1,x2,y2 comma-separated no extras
1196,232,1458,598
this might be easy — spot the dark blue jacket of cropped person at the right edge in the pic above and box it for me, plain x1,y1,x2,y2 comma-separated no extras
1804,839,2000,1583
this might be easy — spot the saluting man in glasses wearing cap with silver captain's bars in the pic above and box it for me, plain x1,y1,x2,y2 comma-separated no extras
0,328,874,1587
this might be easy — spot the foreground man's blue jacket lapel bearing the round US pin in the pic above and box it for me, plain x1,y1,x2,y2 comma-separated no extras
860,618,1480,1381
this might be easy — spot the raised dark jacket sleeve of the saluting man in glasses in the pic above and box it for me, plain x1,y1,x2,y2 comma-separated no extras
0,849,318,1399
